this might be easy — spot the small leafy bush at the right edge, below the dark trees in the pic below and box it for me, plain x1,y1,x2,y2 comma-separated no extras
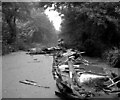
103,48,120,68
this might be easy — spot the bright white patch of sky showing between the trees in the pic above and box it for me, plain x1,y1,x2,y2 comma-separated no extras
45,4,62,31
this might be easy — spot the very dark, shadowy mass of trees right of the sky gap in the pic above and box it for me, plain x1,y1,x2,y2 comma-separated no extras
57,3,120,57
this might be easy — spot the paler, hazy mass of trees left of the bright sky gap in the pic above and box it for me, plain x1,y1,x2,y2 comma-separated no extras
2,2,57,54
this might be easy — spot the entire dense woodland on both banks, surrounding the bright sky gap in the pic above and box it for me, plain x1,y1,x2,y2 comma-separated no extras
2,2,120,67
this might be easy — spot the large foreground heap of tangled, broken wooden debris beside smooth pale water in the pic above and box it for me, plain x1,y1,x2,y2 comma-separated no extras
52,49,120,99
